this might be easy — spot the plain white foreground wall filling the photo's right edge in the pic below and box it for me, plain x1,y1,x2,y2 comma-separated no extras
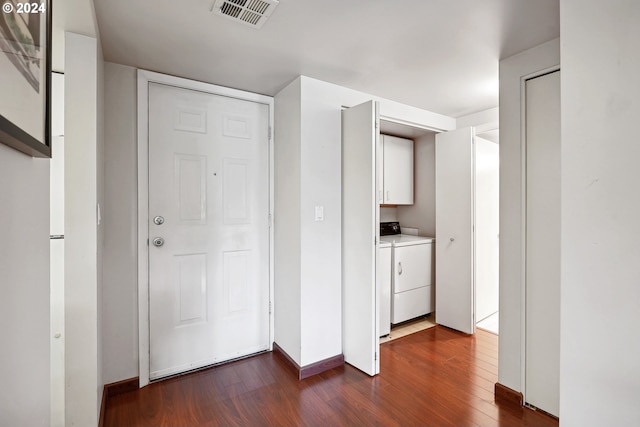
560,0,640,426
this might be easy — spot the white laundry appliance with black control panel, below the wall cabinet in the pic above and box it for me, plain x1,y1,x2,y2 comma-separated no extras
381,222,435,324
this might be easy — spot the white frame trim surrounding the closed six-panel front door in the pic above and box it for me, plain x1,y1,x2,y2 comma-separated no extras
137,70,274,387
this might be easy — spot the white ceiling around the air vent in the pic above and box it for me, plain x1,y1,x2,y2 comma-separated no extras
94,0,560,117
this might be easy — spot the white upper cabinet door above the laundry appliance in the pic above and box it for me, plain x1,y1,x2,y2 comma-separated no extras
383,135,413,205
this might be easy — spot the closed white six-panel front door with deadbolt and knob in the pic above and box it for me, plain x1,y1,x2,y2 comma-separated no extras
148,83,269,379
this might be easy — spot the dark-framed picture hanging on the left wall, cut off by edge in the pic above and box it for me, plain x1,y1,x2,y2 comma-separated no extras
0,0,52,157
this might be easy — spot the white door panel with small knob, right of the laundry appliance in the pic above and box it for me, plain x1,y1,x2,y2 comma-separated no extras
436,128,475,334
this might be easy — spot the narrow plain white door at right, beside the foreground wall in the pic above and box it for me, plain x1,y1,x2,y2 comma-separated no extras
524,71,560,416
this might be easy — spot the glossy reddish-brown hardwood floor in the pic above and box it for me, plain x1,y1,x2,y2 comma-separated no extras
104,326,558,427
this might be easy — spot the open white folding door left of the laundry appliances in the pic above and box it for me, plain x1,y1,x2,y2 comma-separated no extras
342,101,380,375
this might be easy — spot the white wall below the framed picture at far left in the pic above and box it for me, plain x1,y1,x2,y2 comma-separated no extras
0,144,50,426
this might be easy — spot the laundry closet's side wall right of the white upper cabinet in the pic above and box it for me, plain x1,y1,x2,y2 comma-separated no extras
397,133,436,237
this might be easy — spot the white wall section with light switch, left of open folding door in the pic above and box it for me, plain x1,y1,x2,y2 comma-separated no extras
298,78,342,366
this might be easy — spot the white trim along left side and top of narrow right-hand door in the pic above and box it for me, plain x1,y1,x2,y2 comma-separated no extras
520,65,560,403
